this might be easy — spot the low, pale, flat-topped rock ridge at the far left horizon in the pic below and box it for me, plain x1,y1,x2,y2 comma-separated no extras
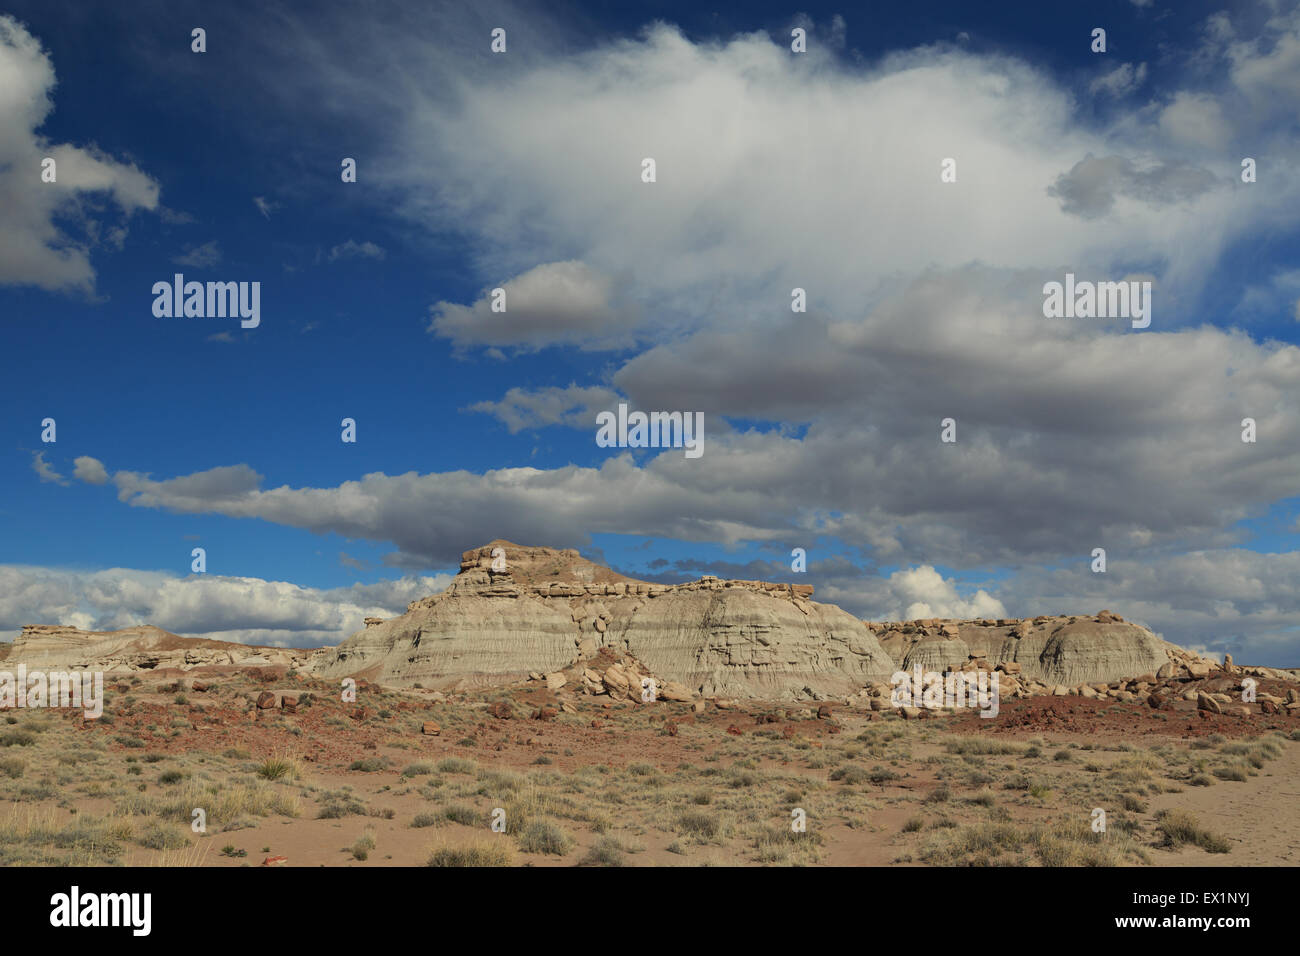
0,624,312,674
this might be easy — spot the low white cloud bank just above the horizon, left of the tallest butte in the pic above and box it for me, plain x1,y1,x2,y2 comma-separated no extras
0,564,451,648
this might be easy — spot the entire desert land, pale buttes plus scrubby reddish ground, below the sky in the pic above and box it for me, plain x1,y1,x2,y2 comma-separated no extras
0,541,1300,866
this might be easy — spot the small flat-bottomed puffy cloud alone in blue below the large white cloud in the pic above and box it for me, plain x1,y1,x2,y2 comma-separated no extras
429,261,637,349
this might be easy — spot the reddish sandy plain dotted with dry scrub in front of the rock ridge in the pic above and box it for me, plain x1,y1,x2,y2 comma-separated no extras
0,672,1300,868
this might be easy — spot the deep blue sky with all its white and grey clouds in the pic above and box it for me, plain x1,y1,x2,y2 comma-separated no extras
0,0,1300,666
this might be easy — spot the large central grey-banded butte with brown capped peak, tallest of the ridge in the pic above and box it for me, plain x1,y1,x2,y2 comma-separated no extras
302,541,894,697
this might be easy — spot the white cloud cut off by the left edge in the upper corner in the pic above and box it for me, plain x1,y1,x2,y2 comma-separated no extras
0,16,159,293
